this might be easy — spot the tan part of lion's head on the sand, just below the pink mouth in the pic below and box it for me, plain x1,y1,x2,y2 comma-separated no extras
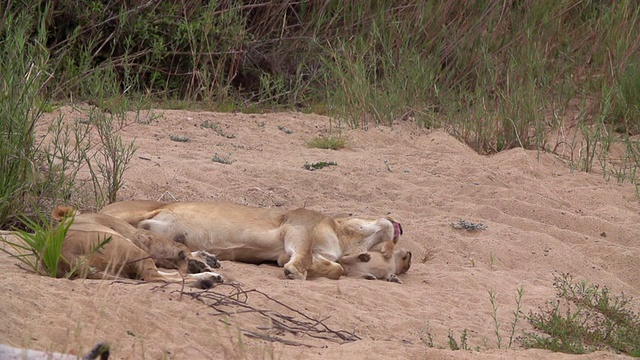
338,248,411,284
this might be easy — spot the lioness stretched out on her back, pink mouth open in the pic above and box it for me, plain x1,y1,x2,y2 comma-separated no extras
100,201,402,279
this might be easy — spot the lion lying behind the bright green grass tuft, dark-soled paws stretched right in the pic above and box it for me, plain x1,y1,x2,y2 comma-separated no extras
52,207,223,288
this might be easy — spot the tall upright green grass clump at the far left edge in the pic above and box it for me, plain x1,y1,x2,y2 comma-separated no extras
0,3,48,226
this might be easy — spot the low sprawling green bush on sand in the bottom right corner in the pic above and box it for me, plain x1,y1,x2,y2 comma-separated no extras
518,273,640,357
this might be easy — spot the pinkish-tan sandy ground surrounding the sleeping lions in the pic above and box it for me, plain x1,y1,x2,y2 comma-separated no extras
0,108,640,359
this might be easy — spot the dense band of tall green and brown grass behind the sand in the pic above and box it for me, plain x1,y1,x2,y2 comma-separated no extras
0,0,640,228
